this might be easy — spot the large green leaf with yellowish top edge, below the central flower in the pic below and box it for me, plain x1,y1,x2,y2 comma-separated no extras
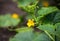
10,28,34,41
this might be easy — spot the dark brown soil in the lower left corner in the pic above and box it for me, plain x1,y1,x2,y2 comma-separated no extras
0,28,16,41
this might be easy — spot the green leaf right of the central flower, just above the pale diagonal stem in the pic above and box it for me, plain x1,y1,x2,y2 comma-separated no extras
37,24,56,34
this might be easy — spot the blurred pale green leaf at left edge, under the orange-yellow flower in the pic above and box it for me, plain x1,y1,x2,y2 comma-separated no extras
0,14,20,27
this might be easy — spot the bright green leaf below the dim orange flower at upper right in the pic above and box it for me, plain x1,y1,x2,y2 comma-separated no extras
38,7,58,17
